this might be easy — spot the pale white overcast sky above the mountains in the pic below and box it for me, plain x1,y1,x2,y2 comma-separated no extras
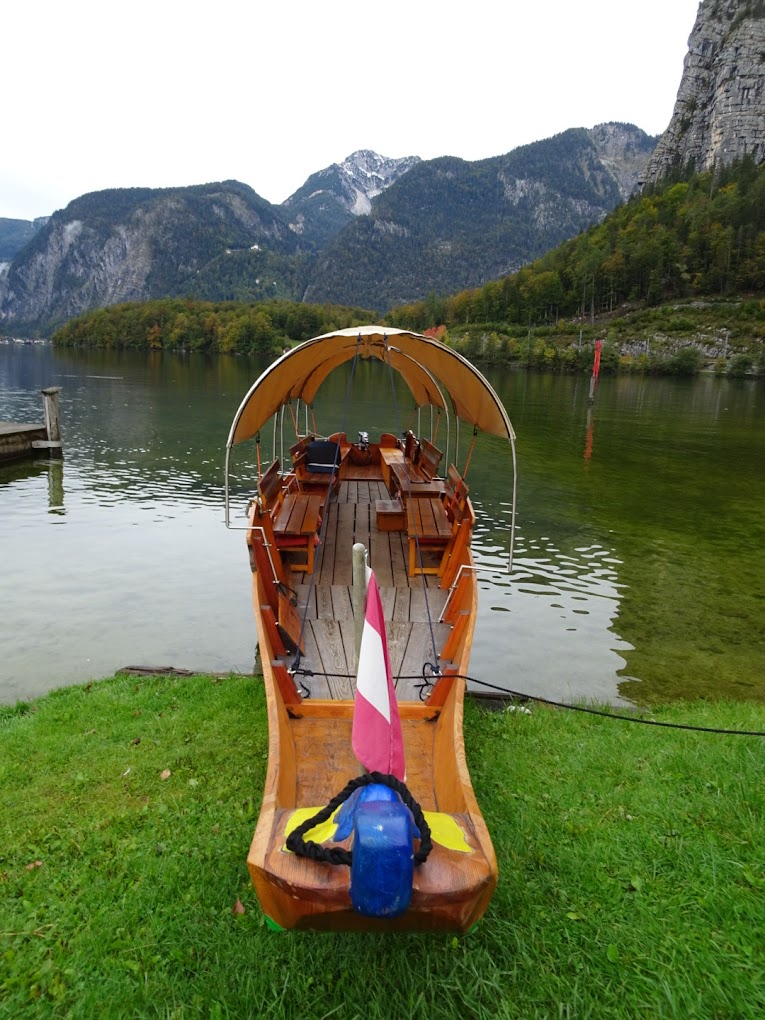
0,0,699,219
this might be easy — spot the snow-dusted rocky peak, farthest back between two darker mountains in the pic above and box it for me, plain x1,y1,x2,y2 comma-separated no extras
283,149,420,250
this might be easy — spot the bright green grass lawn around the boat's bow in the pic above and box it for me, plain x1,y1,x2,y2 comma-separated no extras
0,676,765,1020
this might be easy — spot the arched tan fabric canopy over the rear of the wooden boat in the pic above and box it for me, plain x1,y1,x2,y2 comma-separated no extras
227,325,515,448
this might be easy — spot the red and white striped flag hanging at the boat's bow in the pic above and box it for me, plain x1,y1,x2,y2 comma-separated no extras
352,568,406,782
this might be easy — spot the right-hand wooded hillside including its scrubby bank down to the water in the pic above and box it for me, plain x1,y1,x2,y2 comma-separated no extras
388,158,765,375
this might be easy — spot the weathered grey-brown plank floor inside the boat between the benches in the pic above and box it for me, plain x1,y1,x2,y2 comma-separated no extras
281,475,450,701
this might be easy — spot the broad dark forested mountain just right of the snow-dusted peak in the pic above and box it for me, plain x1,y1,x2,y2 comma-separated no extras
303,123,656,311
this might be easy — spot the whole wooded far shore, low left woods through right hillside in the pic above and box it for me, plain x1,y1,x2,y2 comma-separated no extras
54,159,765,374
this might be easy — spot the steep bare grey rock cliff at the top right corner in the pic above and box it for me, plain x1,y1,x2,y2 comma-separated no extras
645,0,765,184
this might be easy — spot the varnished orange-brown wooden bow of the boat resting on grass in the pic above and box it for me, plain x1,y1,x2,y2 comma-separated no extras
248,574,497,931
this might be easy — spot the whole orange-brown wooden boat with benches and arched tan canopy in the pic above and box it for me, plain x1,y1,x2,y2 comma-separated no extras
226,326,514,931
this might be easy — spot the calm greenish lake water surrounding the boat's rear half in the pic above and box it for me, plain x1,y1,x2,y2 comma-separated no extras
0,344,765,704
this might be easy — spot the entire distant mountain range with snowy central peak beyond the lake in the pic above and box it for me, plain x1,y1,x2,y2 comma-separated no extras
0,131,655,332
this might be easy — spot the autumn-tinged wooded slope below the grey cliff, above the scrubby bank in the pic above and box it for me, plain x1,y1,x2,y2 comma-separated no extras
393,158,765,326
